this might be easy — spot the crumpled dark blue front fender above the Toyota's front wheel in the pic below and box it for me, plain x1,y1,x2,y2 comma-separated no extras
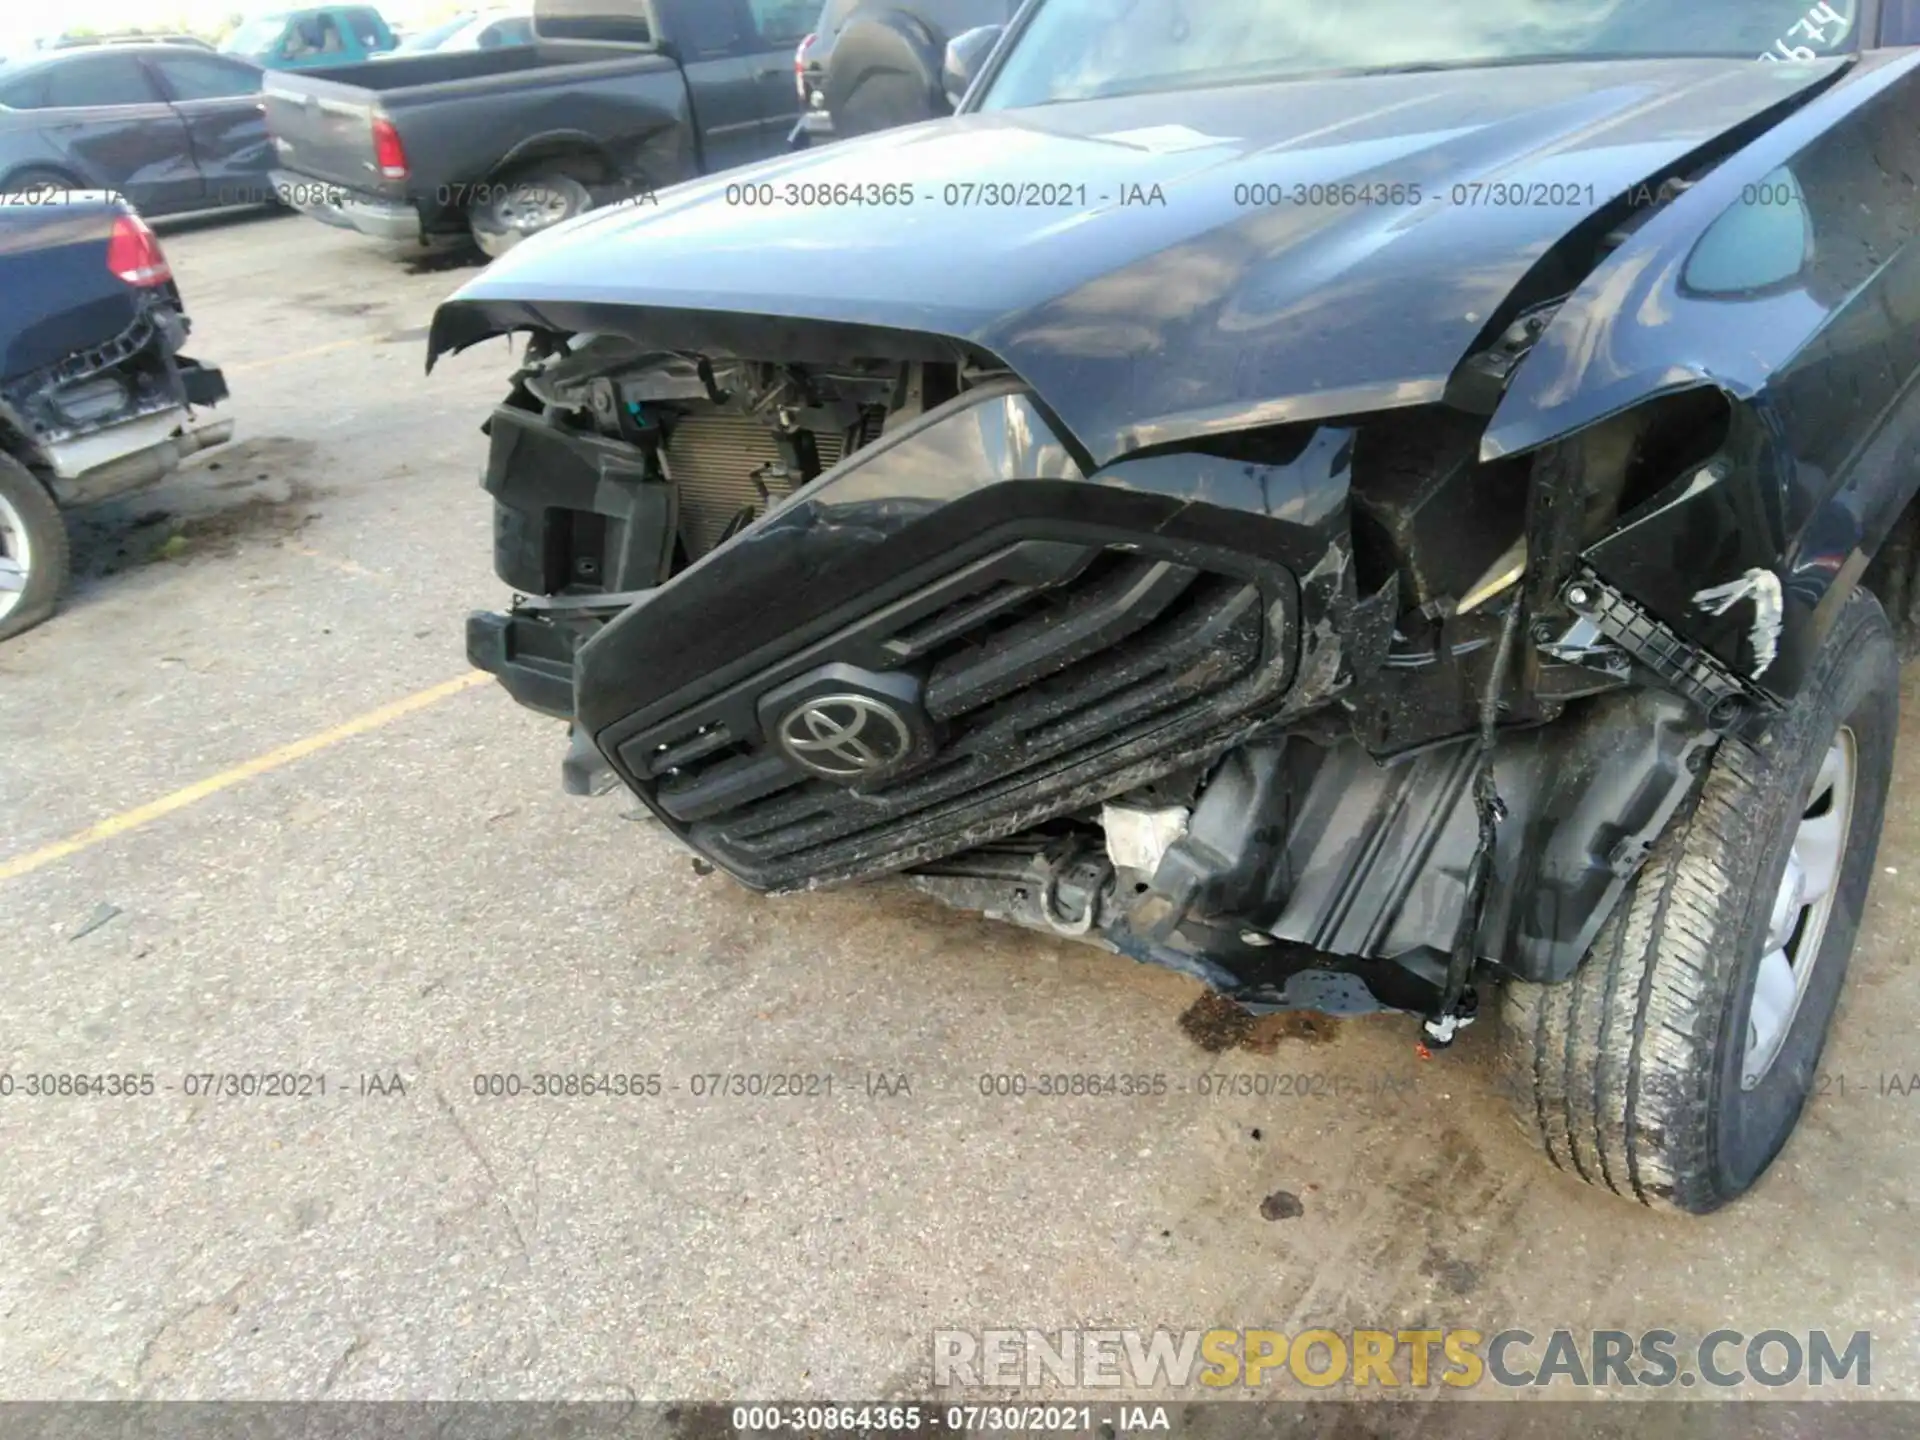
1480,52,1920,699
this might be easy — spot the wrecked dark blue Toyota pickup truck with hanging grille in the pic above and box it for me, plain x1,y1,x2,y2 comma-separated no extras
432,0,1920,1212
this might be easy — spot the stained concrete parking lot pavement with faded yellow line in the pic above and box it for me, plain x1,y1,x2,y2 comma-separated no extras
0,217,1920,1400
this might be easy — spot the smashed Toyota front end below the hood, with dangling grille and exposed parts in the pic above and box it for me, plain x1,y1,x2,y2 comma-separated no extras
445,326,1764,1039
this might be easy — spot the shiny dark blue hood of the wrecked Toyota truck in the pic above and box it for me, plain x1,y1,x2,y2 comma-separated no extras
428,60,1849,463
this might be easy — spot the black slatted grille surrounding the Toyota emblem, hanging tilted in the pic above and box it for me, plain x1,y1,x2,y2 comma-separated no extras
618,540,1292,887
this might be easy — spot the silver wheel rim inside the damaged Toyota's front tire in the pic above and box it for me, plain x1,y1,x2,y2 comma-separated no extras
1740,726,1859,1091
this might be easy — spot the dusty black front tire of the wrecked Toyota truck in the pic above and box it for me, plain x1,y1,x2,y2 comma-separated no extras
1500,591,1899,1215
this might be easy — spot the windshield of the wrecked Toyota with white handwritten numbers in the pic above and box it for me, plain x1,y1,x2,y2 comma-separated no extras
981,0,1862,109
